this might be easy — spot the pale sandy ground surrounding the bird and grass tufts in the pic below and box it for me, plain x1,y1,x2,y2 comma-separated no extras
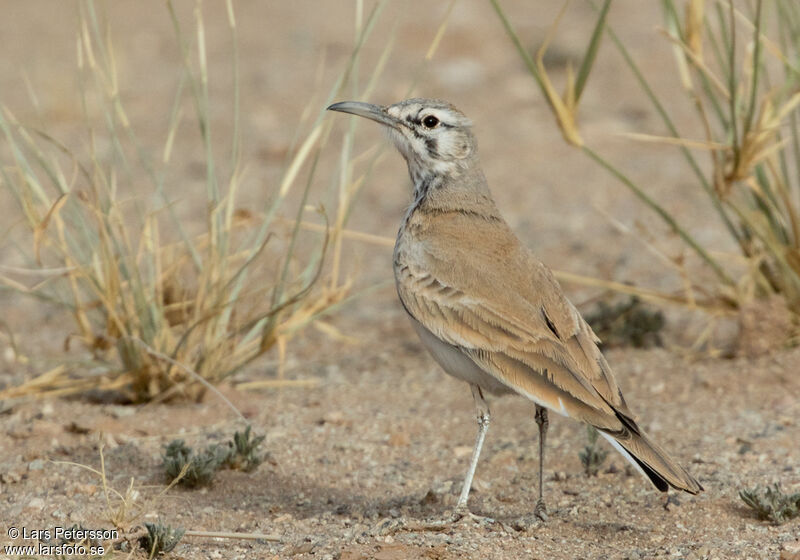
0,0,800,560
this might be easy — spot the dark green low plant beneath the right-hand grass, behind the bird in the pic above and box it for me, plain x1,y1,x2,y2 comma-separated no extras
586,296,664,348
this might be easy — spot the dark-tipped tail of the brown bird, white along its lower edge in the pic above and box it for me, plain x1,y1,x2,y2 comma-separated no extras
598,418,703,494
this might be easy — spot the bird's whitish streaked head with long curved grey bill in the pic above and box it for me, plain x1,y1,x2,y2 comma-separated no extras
328,99,477,183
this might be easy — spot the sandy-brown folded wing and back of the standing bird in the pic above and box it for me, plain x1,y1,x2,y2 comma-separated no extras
396,212,635,432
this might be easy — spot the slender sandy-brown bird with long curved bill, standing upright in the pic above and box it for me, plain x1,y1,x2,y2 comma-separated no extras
328,98,703,520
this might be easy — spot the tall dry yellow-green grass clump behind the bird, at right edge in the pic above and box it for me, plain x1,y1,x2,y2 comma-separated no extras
491,0,800,334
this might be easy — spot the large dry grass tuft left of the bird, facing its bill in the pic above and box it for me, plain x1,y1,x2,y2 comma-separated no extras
0,0,375,402
